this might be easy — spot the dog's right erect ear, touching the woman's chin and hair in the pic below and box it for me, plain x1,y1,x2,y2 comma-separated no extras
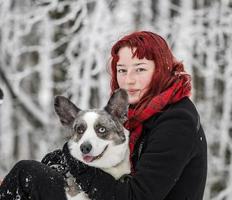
105,89,129,123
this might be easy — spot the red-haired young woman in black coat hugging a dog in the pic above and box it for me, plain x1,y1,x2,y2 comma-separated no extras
0,31,207,200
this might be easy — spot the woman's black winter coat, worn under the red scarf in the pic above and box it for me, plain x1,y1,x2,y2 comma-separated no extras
43,98,207,200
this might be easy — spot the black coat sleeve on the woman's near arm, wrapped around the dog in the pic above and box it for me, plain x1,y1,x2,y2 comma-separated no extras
72,109,196,200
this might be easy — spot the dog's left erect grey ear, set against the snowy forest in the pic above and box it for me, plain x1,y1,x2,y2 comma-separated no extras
54,96,80,127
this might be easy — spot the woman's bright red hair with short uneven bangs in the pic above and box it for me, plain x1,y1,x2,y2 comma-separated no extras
111,31,190,110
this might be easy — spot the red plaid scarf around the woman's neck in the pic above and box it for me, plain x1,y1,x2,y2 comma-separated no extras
125,79,191,173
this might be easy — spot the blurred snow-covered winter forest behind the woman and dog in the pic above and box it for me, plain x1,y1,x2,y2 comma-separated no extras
0,0,232,200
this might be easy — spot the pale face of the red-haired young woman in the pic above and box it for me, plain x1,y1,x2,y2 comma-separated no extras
116,47,155,104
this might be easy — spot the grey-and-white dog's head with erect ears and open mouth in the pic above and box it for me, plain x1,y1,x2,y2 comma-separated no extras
55,89,129,168
